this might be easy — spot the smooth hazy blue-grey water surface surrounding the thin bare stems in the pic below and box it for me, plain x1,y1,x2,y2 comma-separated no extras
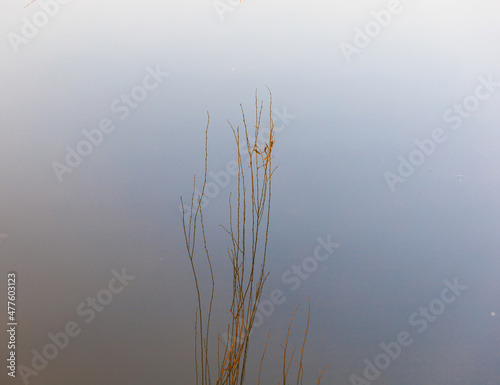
0,0,500,385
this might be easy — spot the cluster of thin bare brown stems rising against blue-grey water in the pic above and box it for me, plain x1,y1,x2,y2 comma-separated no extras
181,88,326,385
